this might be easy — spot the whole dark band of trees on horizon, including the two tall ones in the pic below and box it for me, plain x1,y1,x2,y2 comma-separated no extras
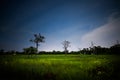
0,33,120,55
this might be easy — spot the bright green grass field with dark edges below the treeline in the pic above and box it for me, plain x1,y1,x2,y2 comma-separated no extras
0,55,120,80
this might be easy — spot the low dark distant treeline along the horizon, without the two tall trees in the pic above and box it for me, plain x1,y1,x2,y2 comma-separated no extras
0,44,120,55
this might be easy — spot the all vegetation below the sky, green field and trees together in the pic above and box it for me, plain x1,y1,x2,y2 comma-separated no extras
0,34,120,80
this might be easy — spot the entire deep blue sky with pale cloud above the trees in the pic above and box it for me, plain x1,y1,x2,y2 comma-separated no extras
0,0,120,51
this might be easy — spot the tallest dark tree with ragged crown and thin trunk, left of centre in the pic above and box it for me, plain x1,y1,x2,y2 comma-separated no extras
30,33,45,52
